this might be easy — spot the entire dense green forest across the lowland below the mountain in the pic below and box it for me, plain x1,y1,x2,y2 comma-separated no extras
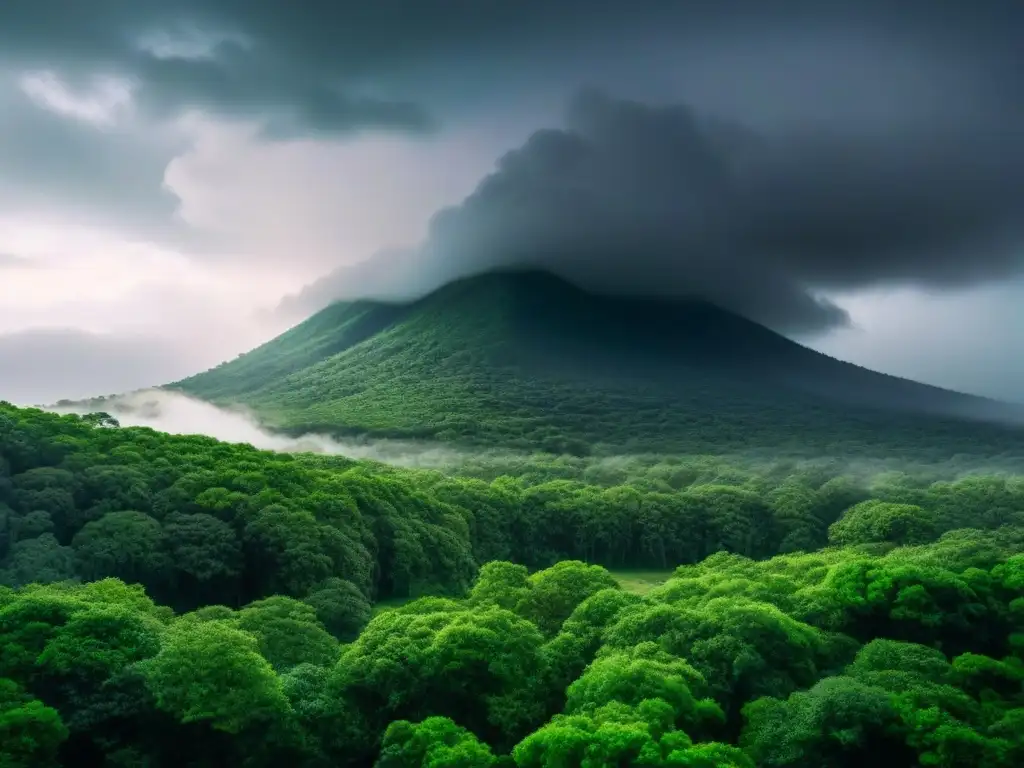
0,403,1024,768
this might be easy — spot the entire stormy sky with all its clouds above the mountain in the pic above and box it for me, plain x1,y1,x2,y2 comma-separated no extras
0,0,1024,403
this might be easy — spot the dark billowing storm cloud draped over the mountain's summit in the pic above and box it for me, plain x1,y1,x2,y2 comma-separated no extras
286,85,1024,332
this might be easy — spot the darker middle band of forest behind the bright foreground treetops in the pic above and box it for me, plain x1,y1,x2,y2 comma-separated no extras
0,406,1024,609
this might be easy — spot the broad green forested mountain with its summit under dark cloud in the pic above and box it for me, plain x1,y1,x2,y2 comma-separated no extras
168,271,1024,458
